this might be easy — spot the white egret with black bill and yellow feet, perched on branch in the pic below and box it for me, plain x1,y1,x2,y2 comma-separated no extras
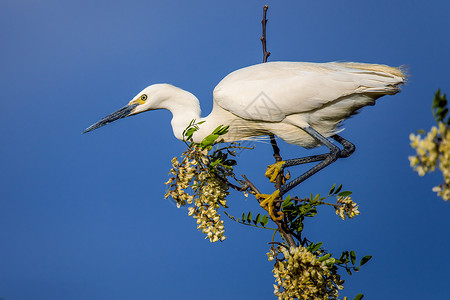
84,62,405,218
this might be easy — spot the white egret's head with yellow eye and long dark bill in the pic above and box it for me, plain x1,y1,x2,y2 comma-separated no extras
83,84,176,133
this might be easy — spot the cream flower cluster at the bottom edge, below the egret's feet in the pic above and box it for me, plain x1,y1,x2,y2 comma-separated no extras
267,246,344,300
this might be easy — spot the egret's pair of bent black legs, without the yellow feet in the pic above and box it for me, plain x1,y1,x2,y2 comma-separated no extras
279,127,355,196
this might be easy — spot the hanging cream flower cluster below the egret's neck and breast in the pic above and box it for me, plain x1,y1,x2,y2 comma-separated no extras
165,144,233,243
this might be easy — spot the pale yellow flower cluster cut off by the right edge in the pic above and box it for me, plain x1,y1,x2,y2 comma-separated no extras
409,122,450,200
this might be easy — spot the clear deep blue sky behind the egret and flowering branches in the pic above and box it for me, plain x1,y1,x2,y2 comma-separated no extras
0,0,450,300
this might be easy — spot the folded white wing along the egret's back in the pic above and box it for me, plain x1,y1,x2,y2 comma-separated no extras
214,62,404,122
